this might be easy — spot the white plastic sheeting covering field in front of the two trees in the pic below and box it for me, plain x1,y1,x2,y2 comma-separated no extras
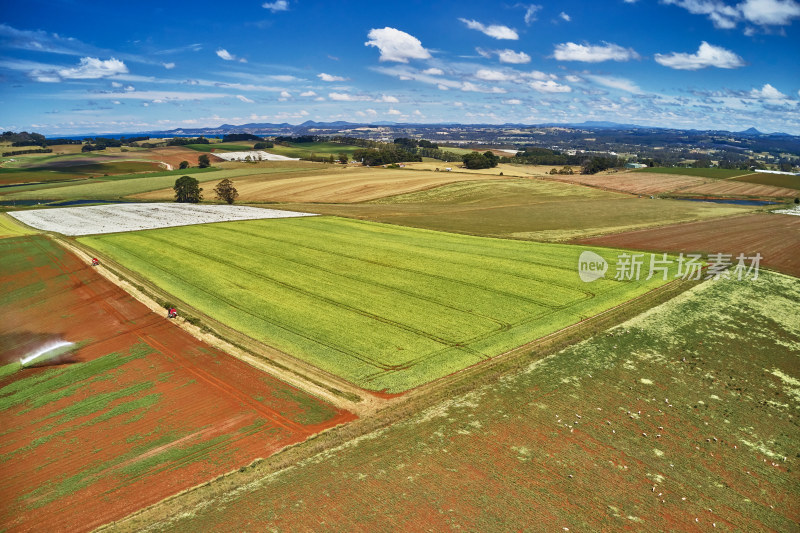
9,203,316,235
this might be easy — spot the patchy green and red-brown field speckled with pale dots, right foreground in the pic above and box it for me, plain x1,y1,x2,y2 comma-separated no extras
145,274,800,532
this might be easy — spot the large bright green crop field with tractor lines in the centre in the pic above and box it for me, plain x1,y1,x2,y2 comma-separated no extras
79,217,680,392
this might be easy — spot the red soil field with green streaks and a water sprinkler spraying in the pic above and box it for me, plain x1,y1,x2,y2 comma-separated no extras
0,236,355,531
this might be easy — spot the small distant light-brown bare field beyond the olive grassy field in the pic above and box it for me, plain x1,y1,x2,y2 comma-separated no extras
550,172,719,195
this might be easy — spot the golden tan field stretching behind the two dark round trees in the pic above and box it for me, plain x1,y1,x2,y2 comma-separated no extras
129,167,510,203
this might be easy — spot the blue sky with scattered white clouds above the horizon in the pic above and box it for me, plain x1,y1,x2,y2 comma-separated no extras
0,0,800,135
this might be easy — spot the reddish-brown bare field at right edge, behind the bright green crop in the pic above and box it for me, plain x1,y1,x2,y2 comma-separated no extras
575,214,800,277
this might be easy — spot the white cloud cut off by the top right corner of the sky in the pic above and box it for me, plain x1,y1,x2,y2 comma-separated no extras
662,0,800,29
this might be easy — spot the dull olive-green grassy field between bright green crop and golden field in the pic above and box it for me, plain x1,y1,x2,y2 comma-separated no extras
278,179,752,241
